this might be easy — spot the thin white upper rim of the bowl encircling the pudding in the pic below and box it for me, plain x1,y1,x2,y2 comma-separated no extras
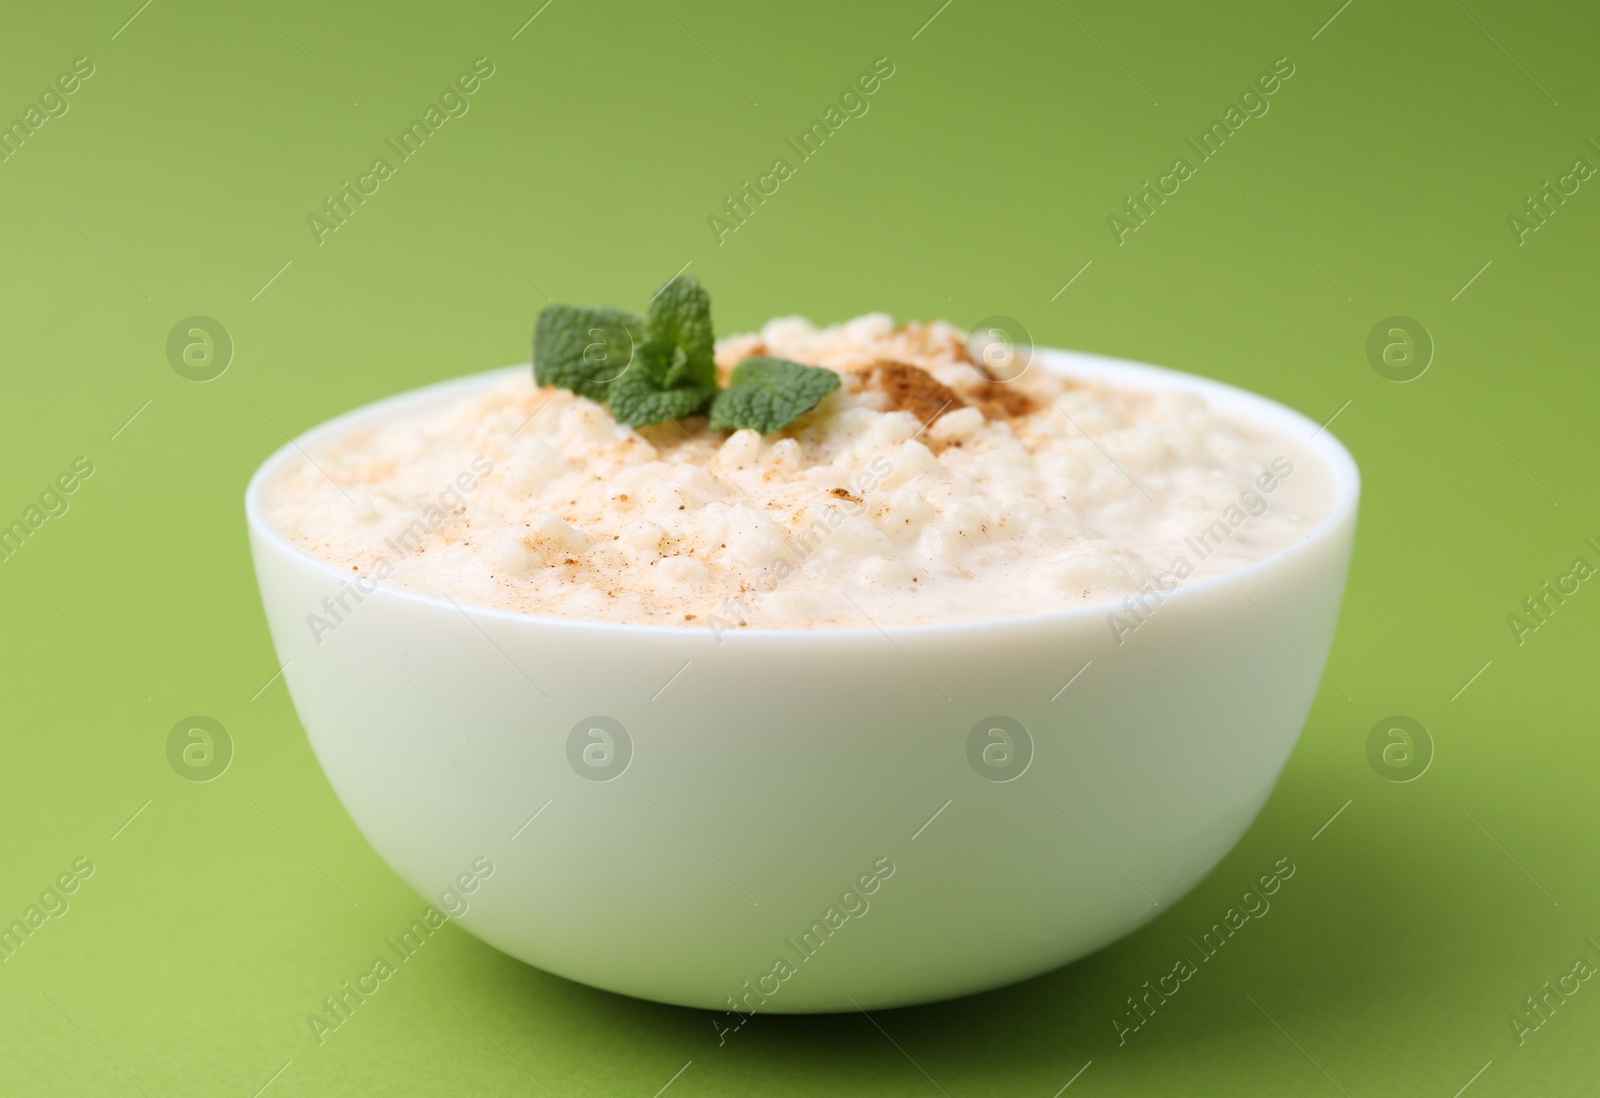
245,347,1362,643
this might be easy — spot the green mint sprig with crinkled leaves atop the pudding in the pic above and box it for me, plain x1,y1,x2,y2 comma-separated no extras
533,277,838,434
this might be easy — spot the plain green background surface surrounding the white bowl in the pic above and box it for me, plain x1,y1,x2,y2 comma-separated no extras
0,0,1600,1098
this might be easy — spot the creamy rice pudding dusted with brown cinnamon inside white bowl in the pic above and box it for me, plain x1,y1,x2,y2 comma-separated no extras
266,314,1333,640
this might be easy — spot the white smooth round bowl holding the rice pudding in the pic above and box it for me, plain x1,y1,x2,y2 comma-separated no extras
245,351,1360,1012
